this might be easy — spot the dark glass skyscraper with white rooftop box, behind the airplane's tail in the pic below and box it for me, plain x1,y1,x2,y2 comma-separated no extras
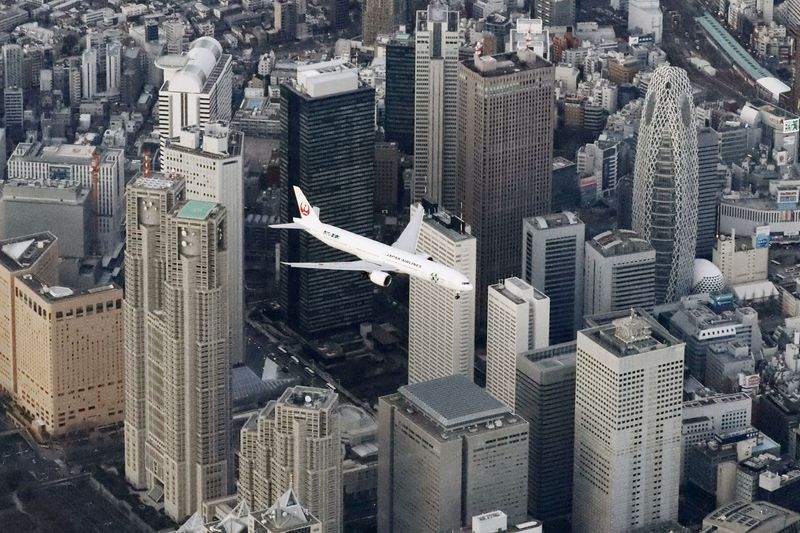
280,61,375,334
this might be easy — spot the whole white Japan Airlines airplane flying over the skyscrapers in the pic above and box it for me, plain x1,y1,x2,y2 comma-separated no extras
270,187,473,299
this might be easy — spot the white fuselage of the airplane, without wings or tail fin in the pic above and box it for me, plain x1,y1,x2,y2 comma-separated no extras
293,218,472,293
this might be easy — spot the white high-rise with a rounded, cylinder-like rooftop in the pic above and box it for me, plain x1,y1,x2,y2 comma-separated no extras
156,37,233,147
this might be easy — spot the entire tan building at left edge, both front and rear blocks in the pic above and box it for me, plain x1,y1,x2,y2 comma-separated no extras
0,232,124,437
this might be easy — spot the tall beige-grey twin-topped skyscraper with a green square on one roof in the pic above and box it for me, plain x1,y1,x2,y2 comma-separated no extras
124,174,232,520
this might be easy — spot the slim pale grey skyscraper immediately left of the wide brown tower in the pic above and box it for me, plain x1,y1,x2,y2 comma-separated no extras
412,0,462,207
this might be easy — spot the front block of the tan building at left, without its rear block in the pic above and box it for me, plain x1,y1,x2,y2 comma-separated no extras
13,270,125,437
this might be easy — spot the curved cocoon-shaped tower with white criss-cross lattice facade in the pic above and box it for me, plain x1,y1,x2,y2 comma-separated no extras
633,65,698,304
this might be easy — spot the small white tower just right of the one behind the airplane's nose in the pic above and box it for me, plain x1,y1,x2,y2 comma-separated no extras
486,278,550,411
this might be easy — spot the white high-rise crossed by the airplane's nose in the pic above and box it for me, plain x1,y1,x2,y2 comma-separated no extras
408,204,476,383
